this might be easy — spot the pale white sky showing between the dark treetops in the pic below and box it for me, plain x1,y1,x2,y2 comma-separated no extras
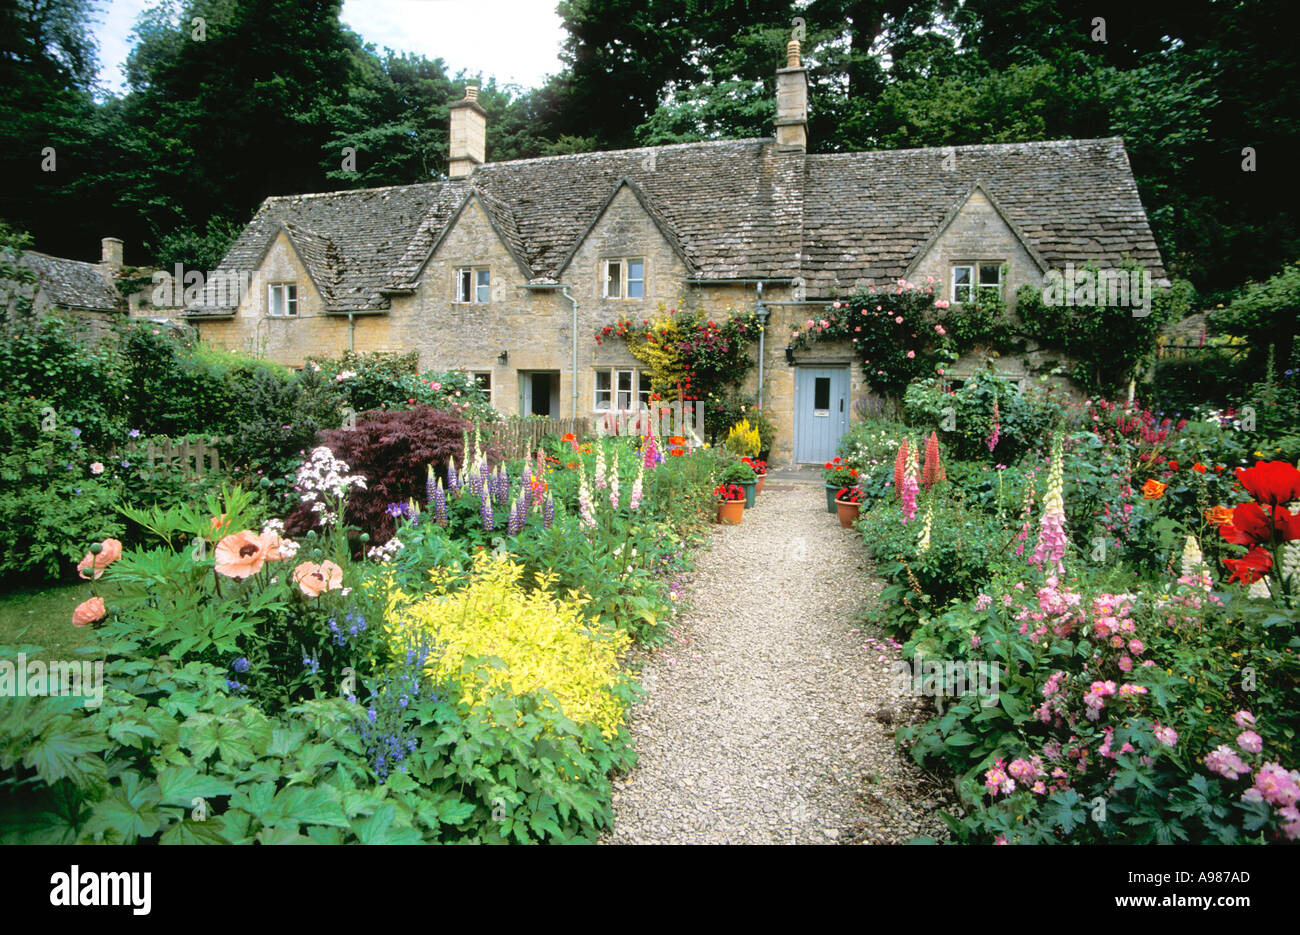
96,0,564,94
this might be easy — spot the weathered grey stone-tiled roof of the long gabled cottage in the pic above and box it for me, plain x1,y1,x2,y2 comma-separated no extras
197,139,1164,311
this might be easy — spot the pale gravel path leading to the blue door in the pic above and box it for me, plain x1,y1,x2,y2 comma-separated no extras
606,482,946,844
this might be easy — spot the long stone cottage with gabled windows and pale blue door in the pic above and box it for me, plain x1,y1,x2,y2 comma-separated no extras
180,42,1164,463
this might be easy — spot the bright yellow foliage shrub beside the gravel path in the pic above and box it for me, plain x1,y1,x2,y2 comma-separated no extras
385,551,631,737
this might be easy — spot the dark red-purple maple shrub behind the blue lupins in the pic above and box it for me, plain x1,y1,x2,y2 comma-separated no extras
285,406,501,545
